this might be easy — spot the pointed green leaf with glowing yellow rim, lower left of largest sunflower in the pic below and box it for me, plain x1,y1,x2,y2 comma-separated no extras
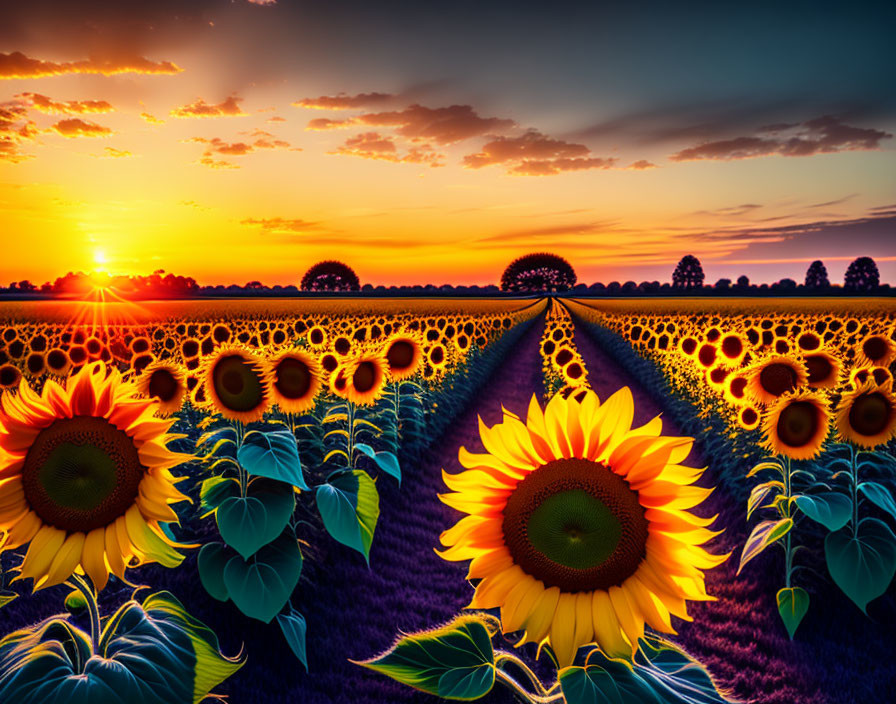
355,614,495,701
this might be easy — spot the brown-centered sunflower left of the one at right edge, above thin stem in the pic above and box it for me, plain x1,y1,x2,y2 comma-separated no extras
762,390,830,460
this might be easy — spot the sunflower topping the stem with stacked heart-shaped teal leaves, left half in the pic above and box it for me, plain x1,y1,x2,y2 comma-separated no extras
202,344,271,423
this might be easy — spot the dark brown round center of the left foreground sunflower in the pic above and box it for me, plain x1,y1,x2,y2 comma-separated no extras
22,416,144,533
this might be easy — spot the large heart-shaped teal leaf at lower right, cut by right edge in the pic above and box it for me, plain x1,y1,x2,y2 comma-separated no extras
824,518,896,611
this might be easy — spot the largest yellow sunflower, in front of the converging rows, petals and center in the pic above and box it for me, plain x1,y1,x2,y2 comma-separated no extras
440,388,727,667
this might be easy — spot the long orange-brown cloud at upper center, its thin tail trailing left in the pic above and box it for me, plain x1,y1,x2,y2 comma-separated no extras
308,104,516,145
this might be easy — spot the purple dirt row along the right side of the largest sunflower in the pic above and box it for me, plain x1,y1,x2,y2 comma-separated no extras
575,320,896,704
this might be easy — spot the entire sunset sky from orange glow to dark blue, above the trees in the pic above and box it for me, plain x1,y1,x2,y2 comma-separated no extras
0,0,896,285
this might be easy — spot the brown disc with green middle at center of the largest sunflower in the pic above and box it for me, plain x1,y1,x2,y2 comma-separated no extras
502,459,647,592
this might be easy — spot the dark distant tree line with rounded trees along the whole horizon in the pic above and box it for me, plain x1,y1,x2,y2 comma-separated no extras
0,252,896,299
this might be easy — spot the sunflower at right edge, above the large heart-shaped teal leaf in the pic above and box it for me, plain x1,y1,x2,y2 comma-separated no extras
835,381,896,448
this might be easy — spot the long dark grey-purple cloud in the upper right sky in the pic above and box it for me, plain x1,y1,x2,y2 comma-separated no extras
669,115,893,161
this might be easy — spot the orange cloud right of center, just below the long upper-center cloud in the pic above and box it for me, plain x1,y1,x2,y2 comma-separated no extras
463,130,617,176
